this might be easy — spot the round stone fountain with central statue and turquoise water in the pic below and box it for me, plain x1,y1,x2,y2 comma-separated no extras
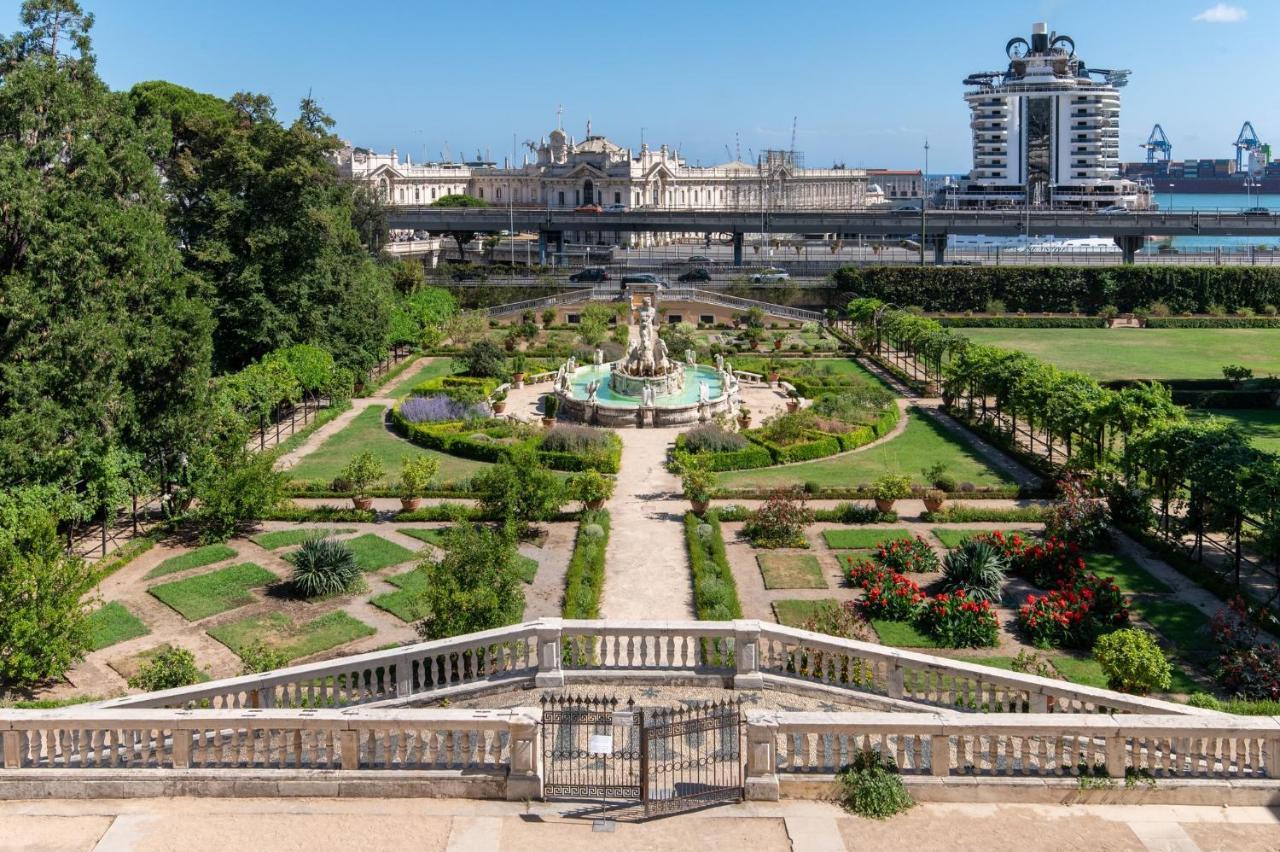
554,297,739,427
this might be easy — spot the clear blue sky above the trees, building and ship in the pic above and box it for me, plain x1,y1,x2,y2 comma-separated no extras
0,0,1280,173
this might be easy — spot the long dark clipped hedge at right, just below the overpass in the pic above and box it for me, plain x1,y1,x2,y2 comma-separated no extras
833,266,1280,313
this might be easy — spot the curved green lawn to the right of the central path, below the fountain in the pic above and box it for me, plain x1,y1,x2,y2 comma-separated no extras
717,406,1014,489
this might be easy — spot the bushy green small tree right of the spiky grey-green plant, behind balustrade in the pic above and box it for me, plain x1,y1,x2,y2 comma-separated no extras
417,522,525,640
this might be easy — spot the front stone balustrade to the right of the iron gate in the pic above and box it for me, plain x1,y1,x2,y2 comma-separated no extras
746,710,1280,800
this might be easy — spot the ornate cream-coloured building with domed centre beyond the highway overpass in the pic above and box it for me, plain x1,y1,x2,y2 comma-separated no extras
338,123,883,242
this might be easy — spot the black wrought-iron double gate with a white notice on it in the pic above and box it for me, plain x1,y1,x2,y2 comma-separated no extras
543,696,742,816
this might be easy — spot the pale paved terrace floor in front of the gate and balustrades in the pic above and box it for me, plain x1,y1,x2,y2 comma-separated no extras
0,798,1280,852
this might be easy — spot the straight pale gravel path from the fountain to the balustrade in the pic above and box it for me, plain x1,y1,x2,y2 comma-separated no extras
600,429,694,619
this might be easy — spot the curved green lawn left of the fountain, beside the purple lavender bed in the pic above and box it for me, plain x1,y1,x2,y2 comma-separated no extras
288,406,489,487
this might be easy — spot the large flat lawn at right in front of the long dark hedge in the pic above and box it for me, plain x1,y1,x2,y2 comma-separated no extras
961,329,1280,380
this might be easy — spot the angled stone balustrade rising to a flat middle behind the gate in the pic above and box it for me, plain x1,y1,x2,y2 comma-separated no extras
96,618,1221,718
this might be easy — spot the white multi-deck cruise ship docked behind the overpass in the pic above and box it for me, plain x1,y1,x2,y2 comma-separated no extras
947,23,1149,210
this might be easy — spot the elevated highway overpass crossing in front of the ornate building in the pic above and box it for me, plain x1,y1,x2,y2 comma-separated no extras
387,206,1280,265
